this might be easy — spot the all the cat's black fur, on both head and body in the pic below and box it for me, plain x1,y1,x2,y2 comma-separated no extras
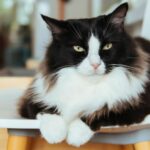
20,4,150,130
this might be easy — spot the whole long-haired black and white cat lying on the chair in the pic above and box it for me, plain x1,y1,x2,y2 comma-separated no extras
19,3,150,146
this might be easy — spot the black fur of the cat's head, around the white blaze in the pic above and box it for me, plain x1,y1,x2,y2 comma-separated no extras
42,4,137,73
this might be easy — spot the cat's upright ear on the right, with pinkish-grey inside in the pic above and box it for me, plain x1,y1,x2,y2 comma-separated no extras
110,3,128,26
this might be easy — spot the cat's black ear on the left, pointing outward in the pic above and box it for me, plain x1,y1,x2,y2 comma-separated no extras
41,15,65,34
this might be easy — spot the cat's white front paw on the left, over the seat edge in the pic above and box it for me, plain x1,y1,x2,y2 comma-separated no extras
37,114,67,144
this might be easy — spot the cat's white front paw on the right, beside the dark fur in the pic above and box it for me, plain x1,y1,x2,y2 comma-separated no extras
66,119,94,147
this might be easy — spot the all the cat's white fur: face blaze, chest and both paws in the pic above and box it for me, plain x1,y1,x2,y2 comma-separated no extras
32,34,148,146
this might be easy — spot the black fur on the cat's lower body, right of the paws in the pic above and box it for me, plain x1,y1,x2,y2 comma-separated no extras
82,83,150,131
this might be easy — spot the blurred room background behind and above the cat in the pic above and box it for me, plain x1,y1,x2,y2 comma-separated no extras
0,0,150,76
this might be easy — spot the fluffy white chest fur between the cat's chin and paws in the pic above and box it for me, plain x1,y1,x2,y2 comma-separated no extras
33,67,147,120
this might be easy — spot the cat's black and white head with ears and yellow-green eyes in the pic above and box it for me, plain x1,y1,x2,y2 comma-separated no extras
42,3,135,76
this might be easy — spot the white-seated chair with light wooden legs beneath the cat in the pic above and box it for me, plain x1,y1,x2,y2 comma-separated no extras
0,77,150,150
